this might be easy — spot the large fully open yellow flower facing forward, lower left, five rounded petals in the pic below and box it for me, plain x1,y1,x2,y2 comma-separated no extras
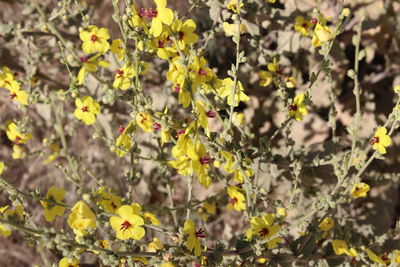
110,203,145,240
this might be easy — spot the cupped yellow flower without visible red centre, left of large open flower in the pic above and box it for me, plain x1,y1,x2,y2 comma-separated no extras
68,200,96,236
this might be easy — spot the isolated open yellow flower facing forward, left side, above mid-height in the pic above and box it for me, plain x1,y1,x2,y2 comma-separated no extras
74,96,100,125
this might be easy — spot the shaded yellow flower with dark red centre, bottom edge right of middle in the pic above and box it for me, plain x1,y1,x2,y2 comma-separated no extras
246,213,281,249
